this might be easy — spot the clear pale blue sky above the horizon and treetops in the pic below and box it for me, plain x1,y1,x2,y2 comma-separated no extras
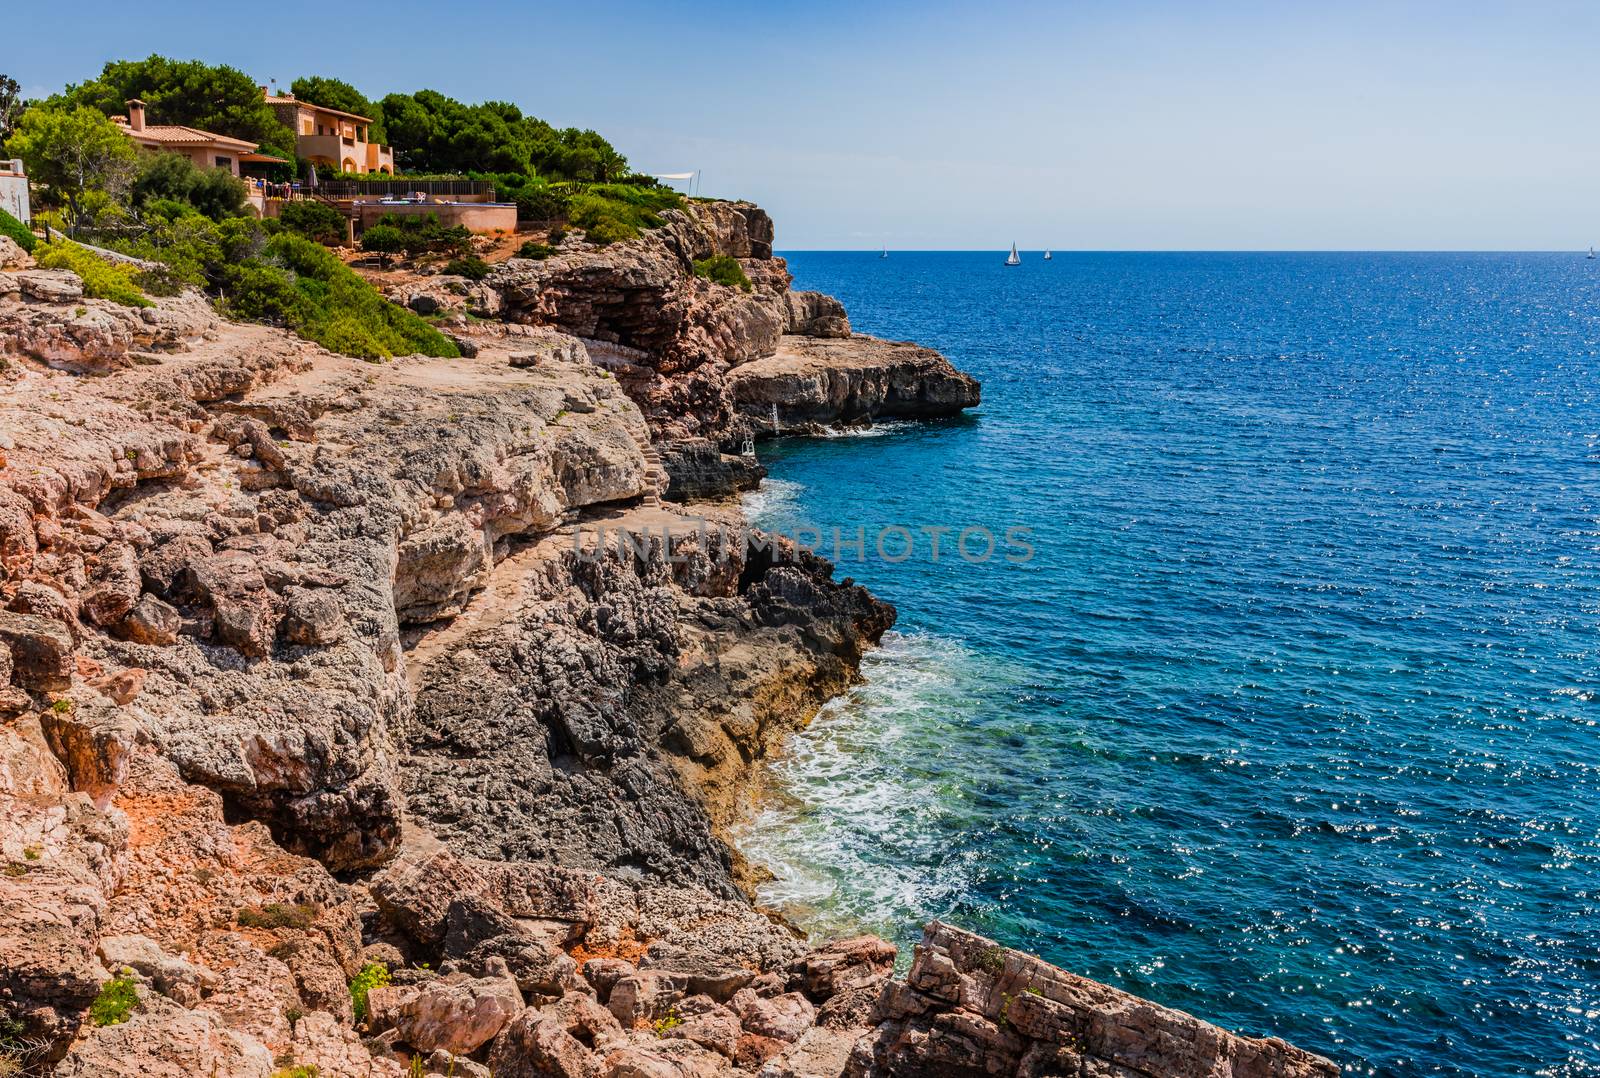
0,0,1600,250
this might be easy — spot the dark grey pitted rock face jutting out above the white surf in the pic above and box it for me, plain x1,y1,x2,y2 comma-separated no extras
402,517,893,896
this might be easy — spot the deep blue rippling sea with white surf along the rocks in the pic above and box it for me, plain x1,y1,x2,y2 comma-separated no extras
742,253,1600,1075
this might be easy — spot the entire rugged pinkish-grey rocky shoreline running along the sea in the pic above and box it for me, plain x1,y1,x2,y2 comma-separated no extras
0,212,1336,1078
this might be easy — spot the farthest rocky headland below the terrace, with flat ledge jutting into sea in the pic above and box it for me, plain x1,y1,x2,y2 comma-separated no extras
485,203,979,501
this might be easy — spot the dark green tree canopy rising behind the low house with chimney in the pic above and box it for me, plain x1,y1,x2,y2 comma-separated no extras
50,54,294,157
